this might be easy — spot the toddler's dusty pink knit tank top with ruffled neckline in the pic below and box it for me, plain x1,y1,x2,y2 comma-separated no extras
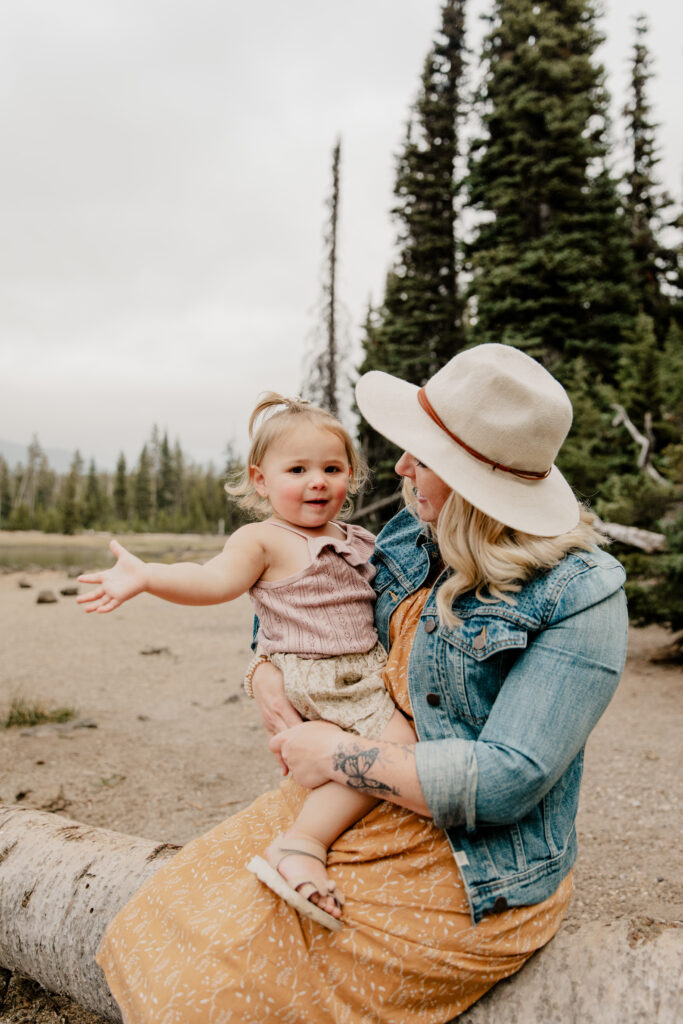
249,522,377,657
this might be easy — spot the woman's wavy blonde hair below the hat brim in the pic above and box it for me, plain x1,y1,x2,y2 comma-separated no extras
403,479,597,626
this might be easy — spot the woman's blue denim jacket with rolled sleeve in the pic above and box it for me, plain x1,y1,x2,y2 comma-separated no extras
373,510,627,924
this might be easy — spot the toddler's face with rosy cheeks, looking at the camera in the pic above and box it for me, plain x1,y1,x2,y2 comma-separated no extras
250,423,350,529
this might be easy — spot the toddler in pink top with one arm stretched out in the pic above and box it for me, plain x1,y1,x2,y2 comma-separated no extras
78,392,416,930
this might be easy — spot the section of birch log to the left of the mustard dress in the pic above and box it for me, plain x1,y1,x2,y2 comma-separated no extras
0,805,178,1021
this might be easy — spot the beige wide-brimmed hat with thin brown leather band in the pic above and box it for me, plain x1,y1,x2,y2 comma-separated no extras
355,344,579,537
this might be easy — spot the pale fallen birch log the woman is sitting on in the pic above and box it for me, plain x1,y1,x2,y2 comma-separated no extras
0,806,683,1024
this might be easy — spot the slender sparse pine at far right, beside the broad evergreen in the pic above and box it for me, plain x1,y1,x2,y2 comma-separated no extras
624,14,683,346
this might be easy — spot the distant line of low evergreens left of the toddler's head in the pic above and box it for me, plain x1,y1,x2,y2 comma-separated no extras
0,427,245,534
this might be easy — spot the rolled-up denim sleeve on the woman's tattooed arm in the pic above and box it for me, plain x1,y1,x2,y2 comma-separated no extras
416,590,627,829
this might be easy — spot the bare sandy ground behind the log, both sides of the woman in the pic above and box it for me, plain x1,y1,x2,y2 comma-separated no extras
0,571,683,1024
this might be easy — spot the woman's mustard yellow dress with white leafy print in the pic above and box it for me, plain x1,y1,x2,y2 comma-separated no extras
97,591,571,1024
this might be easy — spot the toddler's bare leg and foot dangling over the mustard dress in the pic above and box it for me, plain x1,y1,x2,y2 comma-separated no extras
270,711,416,918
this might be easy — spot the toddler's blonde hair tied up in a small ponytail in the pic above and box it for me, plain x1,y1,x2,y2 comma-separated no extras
225,391,368,518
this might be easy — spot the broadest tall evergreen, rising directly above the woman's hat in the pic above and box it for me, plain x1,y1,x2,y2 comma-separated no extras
469,0,634,379
